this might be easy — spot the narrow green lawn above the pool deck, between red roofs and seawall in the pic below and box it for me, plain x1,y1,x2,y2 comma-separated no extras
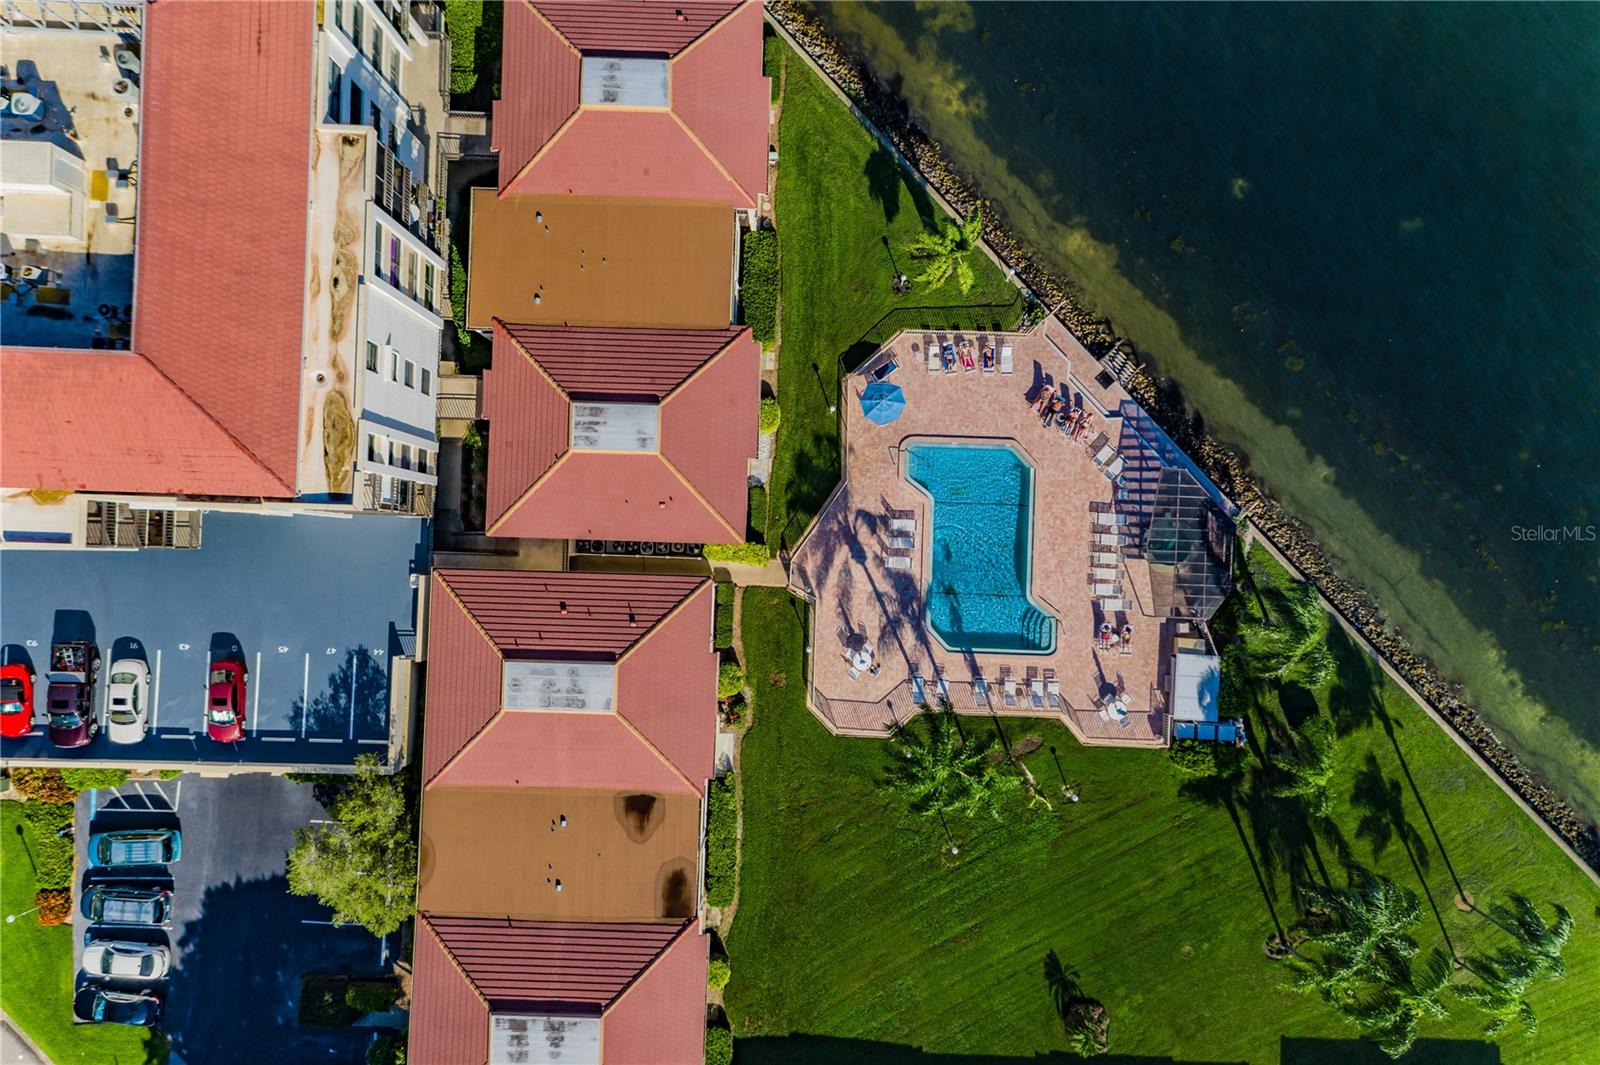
766,43,1022,548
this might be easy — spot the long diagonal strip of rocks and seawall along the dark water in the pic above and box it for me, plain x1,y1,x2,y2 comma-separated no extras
766,0,1600,870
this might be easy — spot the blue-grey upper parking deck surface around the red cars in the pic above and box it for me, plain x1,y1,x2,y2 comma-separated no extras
0,512,427,764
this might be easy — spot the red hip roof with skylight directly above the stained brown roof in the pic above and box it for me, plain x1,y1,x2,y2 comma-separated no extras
422,569,717,792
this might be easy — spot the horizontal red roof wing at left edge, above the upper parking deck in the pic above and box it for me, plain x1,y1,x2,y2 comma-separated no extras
0,347,285,497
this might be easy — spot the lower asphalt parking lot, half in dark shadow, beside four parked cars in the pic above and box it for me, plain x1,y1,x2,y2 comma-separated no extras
76,774,394,1065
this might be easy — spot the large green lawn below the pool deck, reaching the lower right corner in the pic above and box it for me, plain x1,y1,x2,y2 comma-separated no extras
725,562,1600,1065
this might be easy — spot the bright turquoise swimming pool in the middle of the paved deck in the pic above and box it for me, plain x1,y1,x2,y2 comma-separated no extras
906,443,1056,654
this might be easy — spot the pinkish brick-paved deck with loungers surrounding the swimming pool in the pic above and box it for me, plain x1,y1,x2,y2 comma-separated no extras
789,320,1179,747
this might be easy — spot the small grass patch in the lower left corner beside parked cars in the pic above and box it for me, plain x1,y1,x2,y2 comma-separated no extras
0,803,166,1065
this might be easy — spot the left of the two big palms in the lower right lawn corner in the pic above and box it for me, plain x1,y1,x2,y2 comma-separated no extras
1293,865,1422,1004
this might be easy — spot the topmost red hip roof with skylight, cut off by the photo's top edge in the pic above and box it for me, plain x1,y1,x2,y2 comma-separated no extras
494,0,770,208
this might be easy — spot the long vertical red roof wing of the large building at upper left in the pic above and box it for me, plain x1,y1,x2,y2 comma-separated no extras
133,0,322,486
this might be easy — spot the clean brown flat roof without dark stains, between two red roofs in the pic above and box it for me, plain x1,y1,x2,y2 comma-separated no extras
467,189,734,329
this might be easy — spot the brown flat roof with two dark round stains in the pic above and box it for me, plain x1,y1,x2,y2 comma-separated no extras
418,788,699,921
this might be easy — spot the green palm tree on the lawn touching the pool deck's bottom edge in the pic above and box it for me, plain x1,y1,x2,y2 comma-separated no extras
885,704,1018,819
